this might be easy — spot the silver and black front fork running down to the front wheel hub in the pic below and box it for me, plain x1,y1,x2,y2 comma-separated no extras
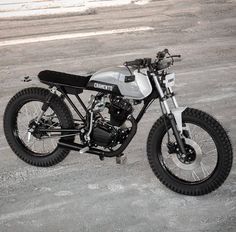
153,76,186,155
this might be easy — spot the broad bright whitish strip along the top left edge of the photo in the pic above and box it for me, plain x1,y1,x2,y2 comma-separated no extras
0,0,149,19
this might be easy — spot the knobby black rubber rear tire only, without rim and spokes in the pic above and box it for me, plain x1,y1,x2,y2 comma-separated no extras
3,87,74,167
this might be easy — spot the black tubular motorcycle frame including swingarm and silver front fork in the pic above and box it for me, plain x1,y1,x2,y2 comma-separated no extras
37,70,185,159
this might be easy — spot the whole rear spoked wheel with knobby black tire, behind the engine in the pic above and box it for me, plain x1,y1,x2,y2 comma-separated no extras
4,88,74,167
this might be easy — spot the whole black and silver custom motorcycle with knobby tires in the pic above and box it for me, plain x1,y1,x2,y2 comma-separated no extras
4,49,233,195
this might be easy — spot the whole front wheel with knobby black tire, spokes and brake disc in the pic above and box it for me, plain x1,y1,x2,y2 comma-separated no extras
147,108,233,196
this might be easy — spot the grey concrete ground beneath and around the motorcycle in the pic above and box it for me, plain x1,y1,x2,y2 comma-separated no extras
0,0,236,232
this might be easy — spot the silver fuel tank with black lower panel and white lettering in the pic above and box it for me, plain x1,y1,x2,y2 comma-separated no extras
87,66,152,100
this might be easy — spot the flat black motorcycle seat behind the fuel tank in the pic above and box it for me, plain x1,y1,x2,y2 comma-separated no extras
38,70,91,88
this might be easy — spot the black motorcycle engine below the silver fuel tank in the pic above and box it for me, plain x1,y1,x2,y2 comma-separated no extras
88,95,133,148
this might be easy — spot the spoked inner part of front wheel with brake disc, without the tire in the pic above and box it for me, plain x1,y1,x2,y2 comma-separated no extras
161,123,218,183
